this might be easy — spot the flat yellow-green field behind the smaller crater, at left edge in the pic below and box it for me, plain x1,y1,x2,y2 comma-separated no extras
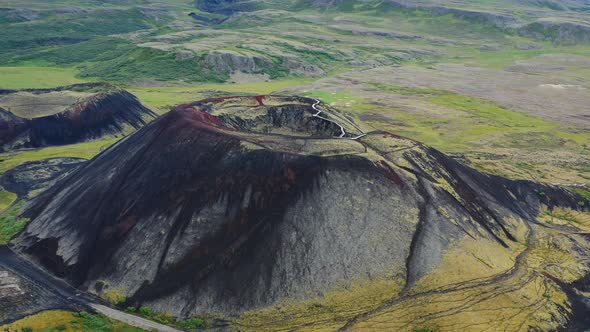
0,66,85,89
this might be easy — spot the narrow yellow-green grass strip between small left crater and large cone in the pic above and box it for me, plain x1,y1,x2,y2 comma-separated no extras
0,138,120,174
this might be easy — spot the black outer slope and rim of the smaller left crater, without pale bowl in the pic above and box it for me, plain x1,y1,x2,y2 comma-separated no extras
0,85,156,150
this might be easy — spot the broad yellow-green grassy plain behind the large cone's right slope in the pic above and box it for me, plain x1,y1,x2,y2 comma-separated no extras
346,85,590,152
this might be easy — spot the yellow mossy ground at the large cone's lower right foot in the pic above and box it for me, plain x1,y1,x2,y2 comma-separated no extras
236,217,588,331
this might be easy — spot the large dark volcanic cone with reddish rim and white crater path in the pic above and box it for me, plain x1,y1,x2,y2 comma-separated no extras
13,96,590,330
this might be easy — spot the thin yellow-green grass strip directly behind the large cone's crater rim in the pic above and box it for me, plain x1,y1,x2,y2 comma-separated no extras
128,78,313,112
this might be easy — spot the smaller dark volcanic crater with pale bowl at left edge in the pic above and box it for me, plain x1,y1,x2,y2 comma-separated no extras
0,83,156,150
